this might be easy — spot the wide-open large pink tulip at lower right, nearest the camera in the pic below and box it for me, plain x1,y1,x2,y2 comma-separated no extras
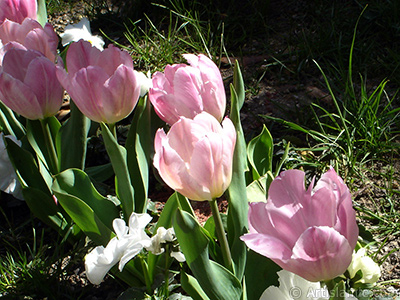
241,168,358,282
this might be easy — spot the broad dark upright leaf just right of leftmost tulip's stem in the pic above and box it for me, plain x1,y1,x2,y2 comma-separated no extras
57,101,90,171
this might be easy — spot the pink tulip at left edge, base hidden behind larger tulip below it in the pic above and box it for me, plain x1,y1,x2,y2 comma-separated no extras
0,18,58,61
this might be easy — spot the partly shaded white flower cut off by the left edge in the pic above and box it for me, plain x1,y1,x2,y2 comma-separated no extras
0,133,24,200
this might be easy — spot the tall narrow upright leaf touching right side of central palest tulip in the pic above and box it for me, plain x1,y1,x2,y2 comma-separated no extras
227,63,248,281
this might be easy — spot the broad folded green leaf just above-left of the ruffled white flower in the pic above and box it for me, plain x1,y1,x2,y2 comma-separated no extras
52,169,119,232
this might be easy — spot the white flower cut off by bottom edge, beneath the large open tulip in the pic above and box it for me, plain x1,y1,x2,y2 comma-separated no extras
260,270,357,300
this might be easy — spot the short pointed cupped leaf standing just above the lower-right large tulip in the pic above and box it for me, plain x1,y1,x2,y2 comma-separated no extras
247,125,274,180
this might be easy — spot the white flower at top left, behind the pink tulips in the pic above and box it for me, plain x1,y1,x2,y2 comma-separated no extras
60,18,104,50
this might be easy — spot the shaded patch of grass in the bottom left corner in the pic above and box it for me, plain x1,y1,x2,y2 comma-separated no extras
0,203,105,299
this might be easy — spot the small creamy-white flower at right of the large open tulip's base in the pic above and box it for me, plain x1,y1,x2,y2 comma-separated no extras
347,248,381,284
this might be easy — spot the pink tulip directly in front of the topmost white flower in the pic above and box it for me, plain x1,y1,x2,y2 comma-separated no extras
57,40,140,124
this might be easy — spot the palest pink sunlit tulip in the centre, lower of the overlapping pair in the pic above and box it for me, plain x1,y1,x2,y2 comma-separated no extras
154,112,236,201
